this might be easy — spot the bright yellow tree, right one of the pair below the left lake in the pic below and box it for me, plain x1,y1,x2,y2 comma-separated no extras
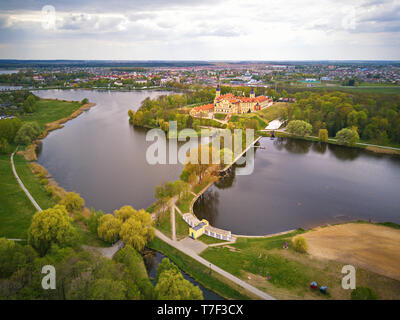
120,209,155,251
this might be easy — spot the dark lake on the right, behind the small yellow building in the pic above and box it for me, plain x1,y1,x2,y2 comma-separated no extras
194,138,400,235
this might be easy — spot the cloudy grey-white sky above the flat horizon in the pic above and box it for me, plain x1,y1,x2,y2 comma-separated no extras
0,0,400,60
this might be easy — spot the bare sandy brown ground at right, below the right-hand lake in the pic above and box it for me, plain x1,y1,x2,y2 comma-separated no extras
302,223,400,280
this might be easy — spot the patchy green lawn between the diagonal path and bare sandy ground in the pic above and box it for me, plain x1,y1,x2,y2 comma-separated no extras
201,230,400,299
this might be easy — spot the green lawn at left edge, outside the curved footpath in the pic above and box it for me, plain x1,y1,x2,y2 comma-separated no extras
0,155,36,239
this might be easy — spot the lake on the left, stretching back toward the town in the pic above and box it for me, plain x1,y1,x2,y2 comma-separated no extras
34,90,183,212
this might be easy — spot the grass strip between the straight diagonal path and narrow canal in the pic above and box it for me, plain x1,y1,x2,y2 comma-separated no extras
147,238,257,300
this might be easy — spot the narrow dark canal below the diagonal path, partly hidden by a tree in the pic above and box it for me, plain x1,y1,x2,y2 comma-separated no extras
144,249,224,300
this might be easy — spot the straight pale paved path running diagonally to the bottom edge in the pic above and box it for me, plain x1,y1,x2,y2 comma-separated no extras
156,230,275,300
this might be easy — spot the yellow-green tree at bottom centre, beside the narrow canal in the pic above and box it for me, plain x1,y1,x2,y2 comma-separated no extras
155,269,203,300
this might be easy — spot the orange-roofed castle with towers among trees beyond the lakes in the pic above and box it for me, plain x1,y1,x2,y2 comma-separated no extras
190,85,272,116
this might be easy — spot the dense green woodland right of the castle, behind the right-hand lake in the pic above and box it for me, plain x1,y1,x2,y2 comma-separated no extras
281,91,400,145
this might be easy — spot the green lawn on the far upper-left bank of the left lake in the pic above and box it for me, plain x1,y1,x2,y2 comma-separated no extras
21,99,81,129
